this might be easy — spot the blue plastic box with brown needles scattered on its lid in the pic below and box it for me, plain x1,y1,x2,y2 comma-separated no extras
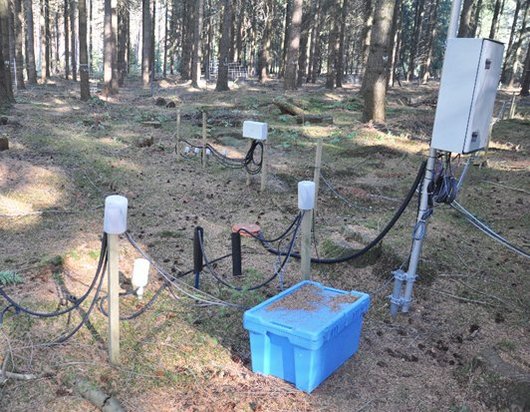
243,281,370,392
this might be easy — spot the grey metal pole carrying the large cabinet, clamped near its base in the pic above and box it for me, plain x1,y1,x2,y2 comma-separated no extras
390,0,462,318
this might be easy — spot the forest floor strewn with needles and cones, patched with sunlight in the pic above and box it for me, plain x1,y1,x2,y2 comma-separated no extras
0,76,530,412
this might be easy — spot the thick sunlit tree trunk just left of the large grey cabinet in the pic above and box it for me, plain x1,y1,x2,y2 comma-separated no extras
362,0,394,123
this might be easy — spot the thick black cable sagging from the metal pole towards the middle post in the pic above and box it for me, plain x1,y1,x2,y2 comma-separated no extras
262,161,427,264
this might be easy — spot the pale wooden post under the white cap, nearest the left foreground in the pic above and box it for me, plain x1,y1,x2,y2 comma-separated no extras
107,235,120,365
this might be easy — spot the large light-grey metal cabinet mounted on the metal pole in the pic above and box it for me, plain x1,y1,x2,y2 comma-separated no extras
431,38,504,154
